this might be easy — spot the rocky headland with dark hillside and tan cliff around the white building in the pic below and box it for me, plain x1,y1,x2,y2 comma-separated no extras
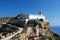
0,14,60,40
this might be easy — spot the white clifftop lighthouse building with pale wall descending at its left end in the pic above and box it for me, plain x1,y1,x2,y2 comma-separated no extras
22,12,45,24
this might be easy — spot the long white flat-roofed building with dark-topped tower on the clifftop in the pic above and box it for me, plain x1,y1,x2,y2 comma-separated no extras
23,12,45,20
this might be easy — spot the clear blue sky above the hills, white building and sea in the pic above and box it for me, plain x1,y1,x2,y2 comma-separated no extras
0,0,60,26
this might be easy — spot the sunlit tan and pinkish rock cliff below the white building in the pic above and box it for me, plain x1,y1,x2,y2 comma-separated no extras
20,21,59,40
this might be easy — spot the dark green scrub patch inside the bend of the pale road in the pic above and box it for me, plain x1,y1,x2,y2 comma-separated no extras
0,24,18,35
